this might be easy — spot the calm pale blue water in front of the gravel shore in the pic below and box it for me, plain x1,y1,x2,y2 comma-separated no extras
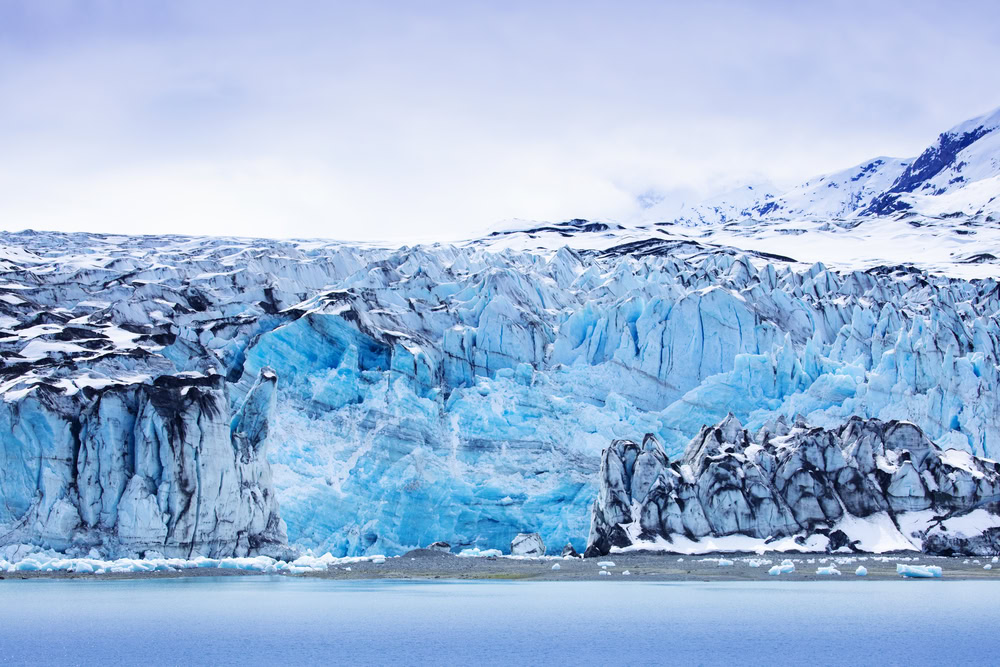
0,577,1000,666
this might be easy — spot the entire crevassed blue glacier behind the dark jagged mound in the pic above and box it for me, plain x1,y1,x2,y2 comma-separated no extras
0,221,1000,555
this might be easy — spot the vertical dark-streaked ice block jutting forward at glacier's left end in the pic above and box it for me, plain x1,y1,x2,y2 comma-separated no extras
0,369,287,557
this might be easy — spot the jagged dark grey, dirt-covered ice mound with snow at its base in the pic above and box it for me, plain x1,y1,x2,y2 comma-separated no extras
587,415,1000,555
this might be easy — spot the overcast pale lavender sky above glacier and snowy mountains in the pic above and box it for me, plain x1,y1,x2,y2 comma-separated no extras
0,0,1000,240
